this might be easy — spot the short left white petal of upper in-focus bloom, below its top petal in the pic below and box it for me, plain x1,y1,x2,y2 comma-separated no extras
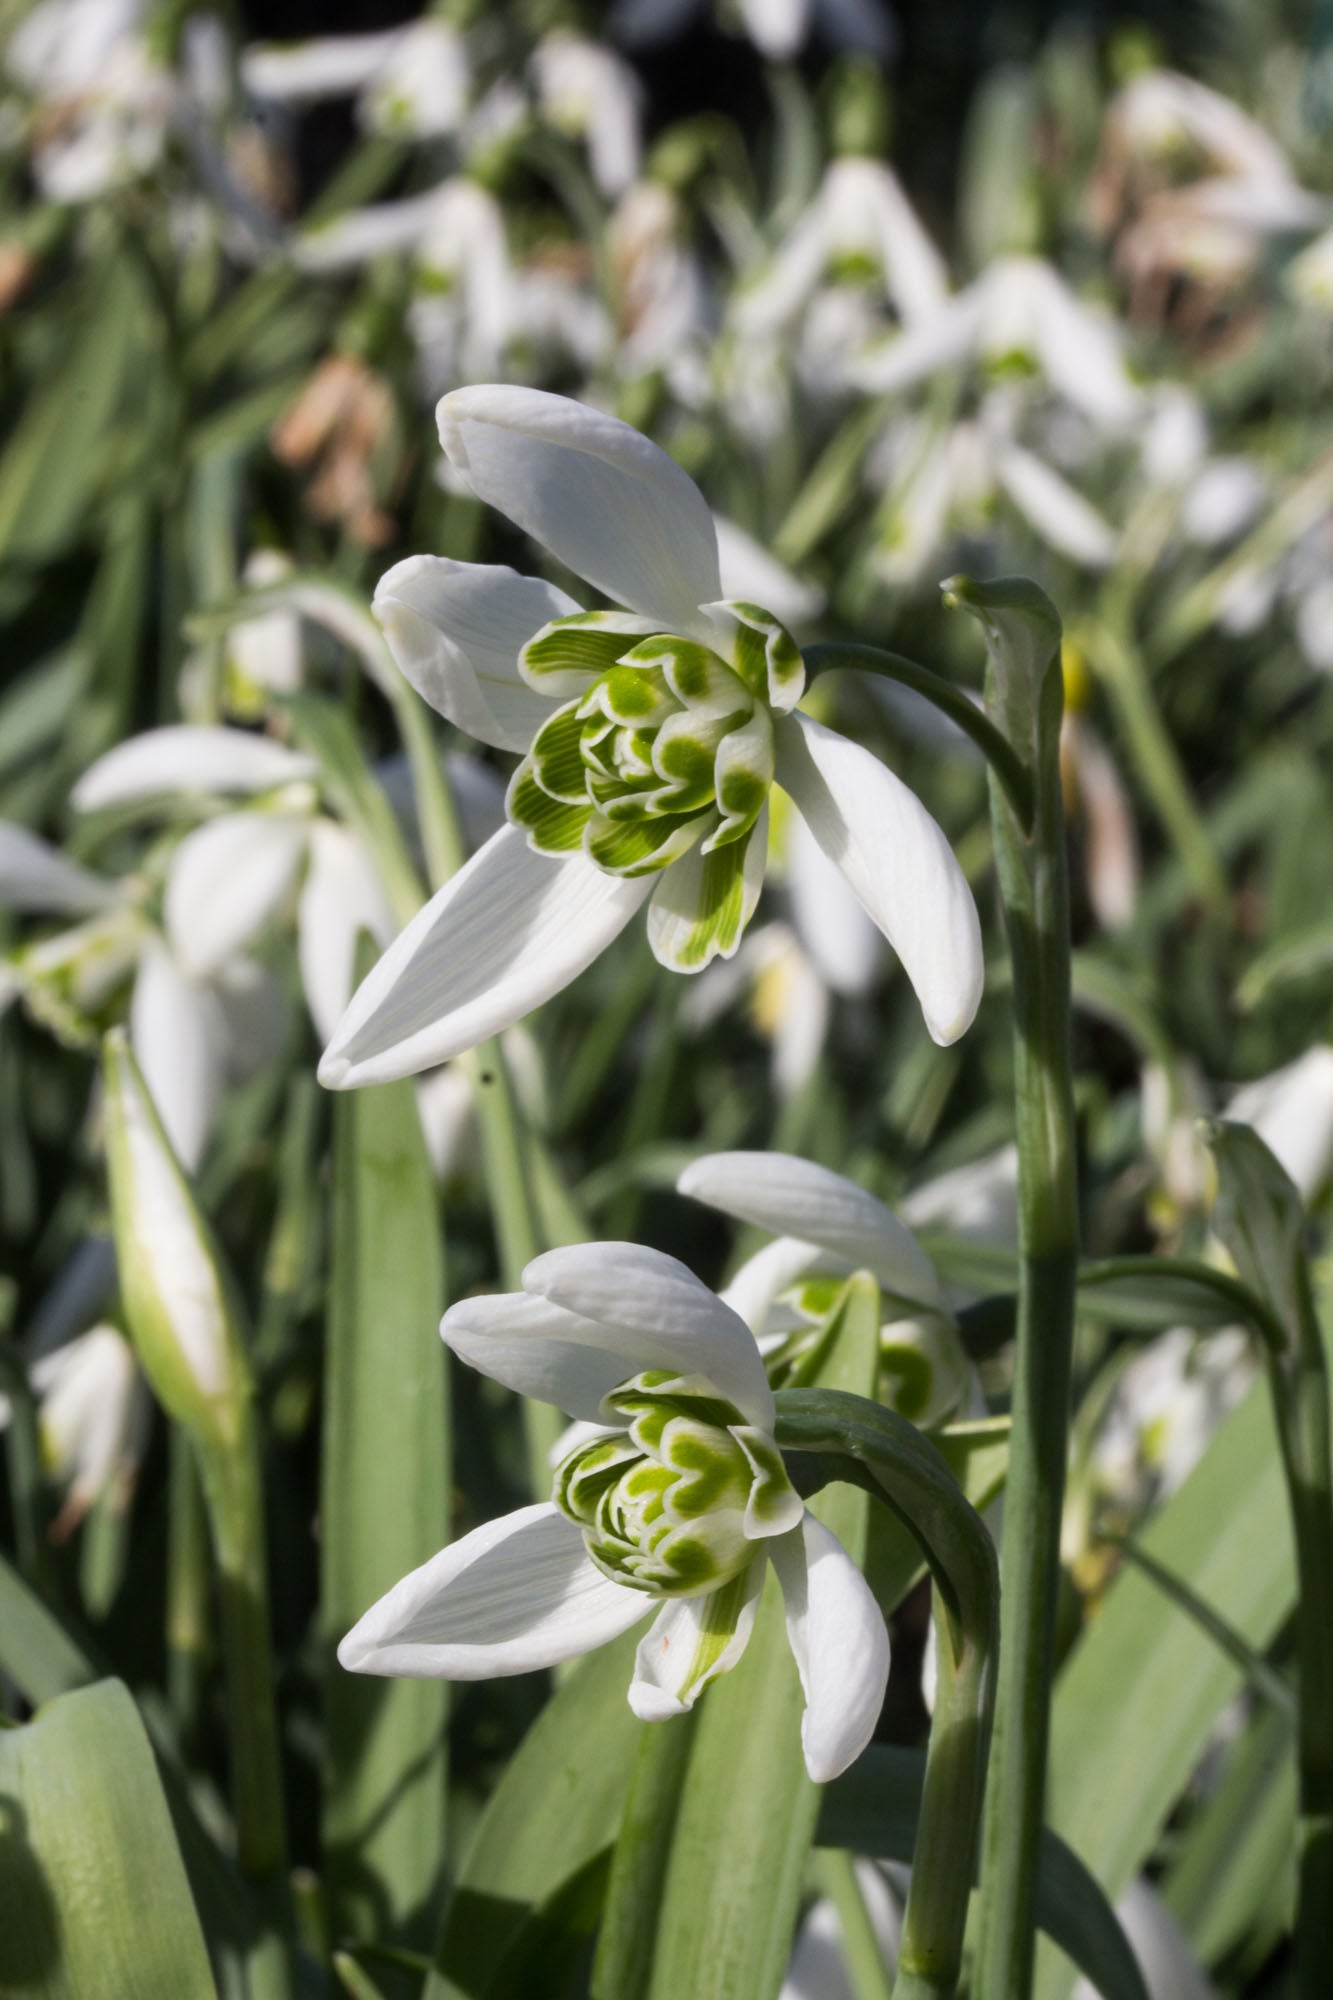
374,556,578,752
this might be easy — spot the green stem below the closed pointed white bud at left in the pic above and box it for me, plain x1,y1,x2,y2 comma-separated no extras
198,1406,294,2000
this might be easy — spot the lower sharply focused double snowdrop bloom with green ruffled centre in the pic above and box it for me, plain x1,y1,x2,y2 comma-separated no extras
338,1244,889,1784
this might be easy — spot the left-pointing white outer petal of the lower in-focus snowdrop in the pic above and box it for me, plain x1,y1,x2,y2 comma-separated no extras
338,1500,652,1680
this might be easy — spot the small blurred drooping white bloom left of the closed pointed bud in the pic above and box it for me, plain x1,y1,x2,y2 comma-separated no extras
0,1324,150,1532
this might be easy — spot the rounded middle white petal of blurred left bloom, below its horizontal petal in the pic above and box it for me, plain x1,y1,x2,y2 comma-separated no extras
162,812,310,978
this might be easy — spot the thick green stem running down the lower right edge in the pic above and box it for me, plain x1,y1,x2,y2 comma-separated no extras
1269,1270,1333,2000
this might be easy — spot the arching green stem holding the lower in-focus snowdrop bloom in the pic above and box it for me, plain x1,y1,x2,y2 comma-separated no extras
775,1390,999,2000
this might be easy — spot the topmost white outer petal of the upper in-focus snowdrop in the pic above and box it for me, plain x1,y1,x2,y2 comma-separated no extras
436,386,723,644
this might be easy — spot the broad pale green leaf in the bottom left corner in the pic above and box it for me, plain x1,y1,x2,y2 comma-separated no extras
0,1680,216,2000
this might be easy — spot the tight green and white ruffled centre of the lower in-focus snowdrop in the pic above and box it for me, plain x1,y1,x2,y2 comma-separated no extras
552,1370,801,1598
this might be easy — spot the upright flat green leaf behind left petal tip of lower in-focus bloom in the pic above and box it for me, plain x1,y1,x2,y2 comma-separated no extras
320,954,448,1938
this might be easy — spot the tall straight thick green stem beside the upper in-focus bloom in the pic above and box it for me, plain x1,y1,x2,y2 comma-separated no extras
961,584,1079,2000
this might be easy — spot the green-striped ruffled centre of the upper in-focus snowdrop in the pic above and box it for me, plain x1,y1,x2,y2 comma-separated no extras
506,604,805,970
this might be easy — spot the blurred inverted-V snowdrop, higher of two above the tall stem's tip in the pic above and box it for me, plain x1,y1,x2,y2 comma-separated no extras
855,256,1143,432
